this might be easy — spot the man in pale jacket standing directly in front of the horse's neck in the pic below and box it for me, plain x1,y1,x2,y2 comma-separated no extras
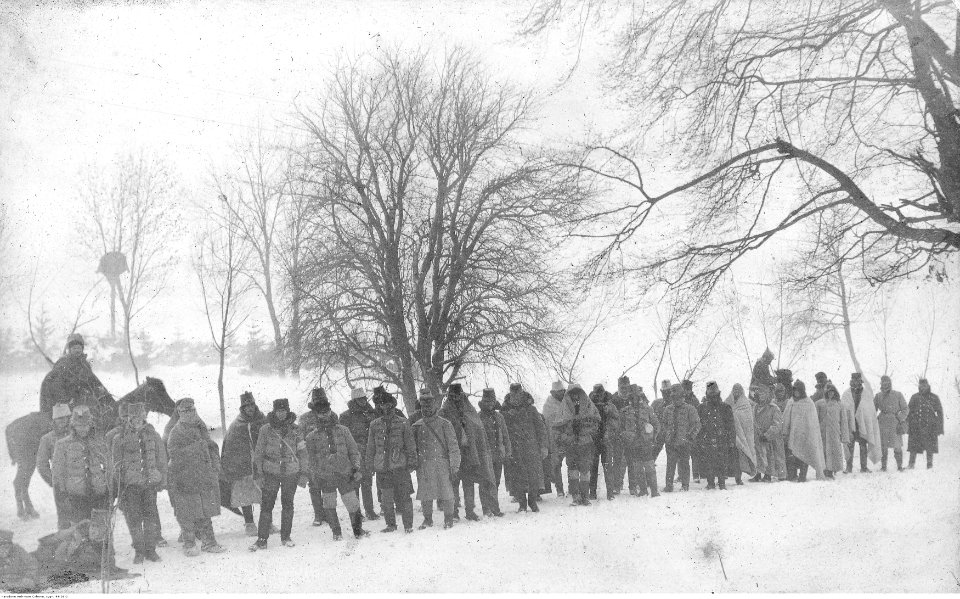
109,403,167,564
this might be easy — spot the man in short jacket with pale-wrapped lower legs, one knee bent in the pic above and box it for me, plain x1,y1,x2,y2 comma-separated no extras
307,397,370,541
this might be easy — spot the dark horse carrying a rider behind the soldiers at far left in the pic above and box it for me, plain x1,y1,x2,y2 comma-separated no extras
6,377,175,520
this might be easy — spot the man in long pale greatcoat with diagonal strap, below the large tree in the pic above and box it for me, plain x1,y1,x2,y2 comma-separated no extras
413,389,460,530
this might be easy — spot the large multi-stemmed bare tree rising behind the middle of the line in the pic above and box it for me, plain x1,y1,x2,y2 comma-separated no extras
300,49,583,409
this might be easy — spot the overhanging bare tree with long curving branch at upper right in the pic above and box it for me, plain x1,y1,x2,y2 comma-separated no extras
524,0,960,308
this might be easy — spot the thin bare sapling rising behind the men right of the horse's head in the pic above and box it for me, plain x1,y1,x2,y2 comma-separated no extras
193,195,250,434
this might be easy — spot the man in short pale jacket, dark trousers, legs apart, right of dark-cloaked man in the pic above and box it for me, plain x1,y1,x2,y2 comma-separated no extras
250,398,309,551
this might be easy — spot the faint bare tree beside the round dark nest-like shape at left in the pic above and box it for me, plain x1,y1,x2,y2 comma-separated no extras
80,153,179,385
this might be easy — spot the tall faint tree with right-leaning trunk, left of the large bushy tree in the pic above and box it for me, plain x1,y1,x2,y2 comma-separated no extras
217,127,289,372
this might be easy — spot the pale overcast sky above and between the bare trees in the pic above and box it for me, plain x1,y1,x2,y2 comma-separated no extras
0,0,958,394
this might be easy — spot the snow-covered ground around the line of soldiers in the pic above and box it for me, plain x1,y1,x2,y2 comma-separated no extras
0,369,960,593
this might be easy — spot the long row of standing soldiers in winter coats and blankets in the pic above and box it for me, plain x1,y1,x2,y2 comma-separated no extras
3,336,943,584
